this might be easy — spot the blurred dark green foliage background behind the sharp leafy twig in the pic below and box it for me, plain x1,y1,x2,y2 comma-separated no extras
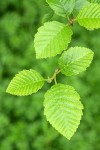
0,0,100,150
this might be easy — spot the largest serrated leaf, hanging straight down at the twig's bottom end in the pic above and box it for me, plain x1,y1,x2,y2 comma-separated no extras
44,84,83,140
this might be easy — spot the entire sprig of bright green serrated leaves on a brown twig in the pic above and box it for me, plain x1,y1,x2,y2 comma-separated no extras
7,0,100,139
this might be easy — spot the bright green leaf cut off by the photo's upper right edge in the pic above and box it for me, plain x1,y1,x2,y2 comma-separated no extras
76,3,100,30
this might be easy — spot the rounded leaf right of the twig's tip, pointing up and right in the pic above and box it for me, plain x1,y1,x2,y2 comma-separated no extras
59,47,94,76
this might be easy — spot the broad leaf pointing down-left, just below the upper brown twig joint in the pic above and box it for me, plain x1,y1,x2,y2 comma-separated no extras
34,21,73,58
